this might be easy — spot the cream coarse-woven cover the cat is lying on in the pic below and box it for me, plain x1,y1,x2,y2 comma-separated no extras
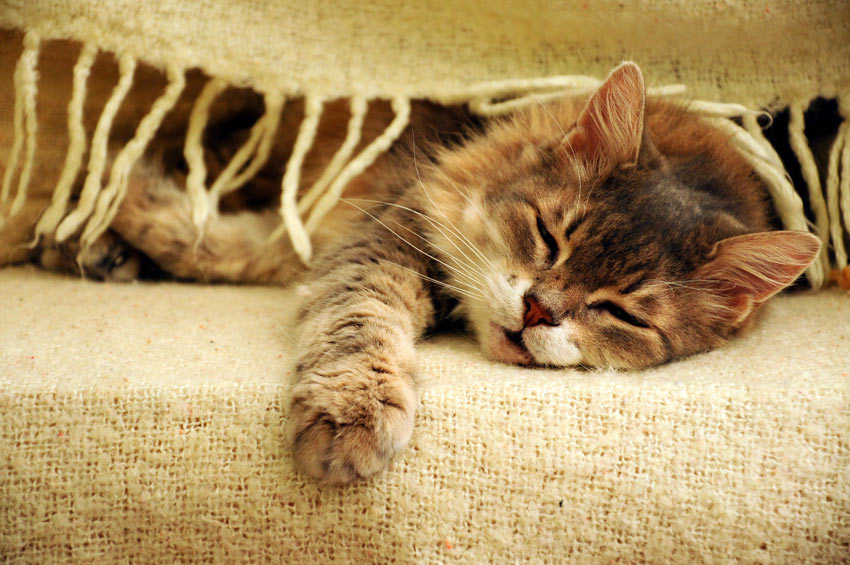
0,268,850,563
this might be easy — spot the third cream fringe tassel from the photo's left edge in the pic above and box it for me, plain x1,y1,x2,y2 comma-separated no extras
56,53,136,242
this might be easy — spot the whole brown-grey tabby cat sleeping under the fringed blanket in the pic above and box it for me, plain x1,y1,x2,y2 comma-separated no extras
21,63,820,483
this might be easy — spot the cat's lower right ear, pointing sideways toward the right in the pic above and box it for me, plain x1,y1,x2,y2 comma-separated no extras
696,231,821,322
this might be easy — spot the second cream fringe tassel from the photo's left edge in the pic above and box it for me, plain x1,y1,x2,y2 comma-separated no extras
33,43,97,240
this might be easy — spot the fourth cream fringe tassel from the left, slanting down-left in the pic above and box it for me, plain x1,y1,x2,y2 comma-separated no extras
82,67,186,248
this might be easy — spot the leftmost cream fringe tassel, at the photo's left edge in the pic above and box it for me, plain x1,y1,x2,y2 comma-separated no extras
0,31,41,226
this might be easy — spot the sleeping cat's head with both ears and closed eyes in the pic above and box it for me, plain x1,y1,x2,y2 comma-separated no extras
423,63,820,368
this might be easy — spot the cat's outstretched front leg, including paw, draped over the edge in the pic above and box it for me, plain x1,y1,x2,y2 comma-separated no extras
287,236,434,484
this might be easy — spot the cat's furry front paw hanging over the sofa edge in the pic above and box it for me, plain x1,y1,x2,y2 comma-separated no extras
287,367,416,484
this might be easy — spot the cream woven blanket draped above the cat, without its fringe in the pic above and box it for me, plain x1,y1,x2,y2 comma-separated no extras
0,0,850,107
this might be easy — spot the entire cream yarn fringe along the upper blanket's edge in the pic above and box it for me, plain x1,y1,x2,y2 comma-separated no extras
0,31,850,288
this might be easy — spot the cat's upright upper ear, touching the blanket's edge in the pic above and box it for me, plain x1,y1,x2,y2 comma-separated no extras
564,62,654,166
